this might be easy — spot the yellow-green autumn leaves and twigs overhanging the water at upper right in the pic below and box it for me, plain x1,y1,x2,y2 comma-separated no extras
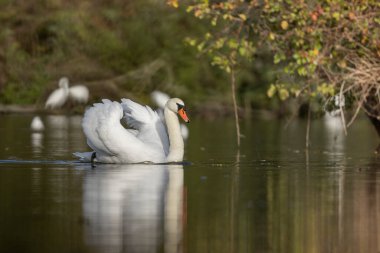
174,0,380,115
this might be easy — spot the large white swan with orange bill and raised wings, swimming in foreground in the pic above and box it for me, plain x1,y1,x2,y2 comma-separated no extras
74,98,189,163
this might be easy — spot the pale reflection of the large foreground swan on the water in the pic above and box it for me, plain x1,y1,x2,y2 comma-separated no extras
83,164,184,252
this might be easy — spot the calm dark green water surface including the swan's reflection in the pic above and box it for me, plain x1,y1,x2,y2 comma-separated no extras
0,115,380,253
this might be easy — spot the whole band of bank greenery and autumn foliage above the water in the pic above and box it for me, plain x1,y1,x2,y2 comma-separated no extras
0,0,380,131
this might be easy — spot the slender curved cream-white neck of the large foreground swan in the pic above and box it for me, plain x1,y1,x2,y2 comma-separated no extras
164,107,184,162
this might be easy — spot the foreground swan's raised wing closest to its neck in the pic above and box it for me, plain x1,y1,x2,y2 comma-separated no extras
121,99,169,156
